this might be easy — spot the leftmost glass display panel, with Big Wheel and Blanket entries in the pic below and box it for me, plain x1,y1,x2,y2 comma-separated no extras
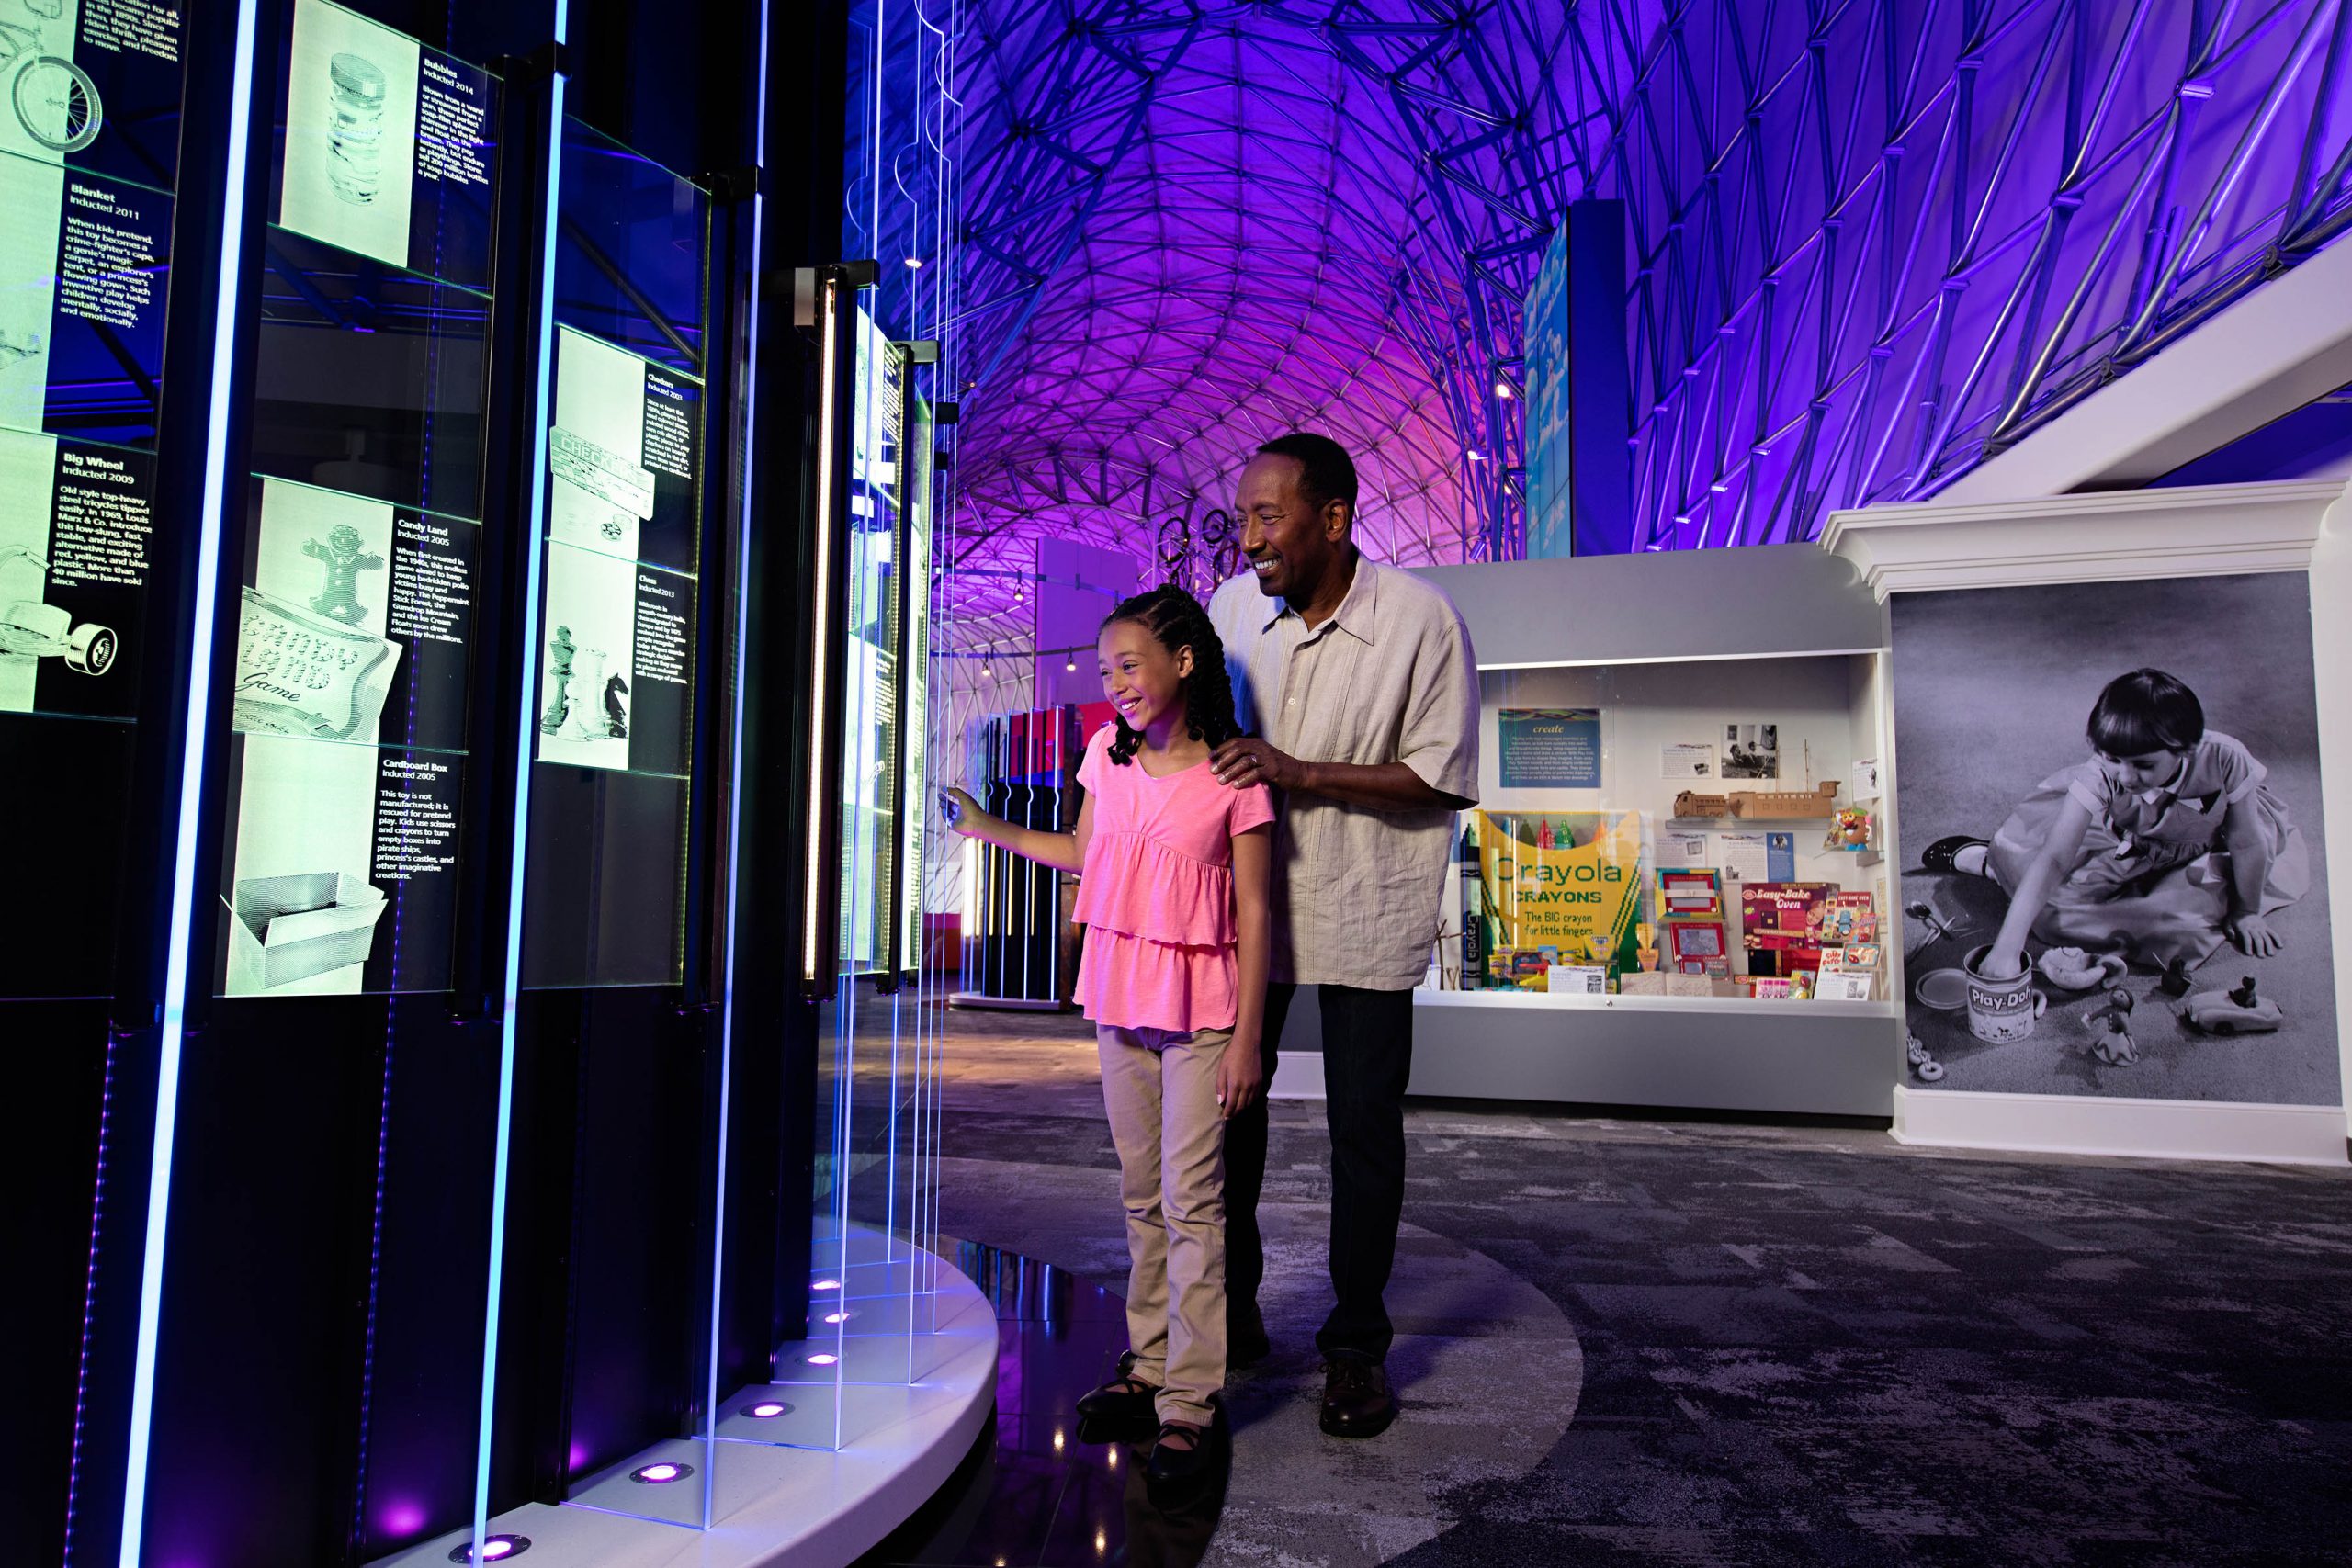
0,0,184,997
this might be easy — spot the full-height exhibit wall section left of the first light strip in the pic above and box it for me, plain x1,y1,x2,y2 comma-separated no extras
0,5,192,1561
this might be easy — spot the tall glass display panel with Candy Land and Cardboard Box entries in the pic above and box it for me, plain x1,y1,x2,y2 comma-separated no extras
214,0,499,997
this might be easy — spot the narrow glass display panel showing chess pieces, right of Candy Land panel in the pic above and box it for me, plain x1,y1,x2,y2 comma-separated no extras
522,120,710,987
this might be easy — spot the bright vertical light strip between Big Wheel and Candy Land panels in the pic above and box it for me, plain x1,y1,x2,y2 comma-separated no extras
120,0,259,1568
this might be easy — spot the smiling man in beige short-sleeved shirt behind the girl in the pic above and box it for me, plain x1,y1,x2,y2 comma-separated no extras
1209,434,1479,1437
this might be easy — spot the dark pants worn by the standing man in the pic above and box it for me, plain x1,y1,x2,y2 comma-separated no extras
1226,985,1414,1363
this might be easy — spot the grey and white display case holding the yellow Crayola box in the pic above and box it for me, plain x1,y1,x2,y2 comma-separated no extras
1275,546,1903,1119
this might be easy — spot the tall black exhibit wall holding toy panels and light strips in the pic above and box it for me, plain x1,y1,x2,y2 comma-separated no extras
0,0,847,1565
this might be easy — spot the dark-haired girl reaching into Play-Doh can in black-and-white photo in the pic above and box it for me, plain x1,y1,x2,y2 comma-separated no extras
1927,670,2312,978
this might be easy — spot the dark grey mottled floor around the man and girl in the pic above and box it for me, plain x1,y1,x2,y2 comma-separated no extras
887,1013,2352,1568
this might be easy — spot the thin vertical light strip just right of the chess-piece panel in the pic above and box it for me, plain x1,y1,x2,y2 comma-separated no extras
703,0,767,1528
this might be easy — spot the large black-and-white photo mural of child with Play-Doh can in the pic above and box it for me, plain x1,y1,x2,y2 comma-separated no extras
1894,573,2338,1105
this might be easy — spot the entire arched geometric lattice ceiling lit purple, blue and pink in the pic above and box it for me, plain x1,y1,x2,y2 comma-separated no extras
953,0,2352,639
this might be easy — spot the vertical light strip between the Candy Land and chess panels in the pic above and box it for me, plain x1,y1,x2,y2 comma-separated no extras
472,0,570,1568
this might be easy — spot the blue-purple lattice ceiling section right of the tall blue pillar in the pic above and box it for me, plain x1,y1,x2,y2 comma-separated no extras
1597,0,2352,547
